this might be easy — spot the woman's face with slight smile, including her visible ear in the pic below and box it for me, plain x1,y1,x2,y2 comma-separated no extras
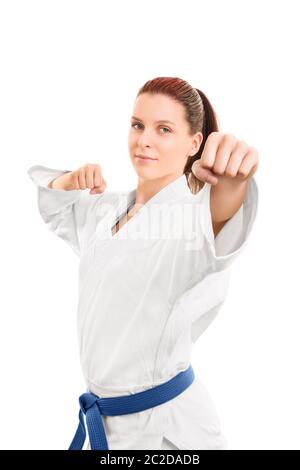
128,93,203,180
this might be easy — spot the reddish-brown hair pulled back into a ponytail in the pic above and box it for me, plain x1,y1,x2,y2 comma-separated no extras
136,77,219,194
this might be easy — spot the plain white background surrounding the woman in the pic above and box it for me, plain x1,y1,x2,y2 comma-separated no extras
0,0,300,449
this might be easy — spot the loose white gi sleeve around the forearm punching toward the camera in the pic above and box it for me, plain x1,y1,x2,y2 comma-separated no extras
200,176,259,271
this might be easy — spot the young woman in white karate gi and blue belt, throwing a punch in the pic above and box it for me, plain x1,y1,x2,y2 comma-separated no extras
28,77,258,450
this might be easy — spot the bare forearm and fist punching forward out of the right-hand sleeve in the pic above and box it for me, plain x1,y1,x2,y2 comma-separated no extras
192,132,258,237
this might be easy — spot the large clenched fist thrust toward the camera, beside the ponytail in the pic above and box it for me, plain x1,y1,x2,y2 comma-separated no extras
192,132,258,185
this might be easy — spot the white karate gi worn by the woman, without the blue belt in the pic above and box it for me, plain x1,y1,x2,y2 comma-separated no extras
28,165,258,450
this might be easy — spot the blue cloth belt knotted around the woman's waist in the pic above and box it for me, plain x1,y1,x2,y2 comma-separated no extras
68,365,195,450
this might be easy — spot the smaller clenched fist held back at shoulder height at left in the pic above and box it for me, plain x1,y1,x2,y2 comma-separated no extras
48,163,106,194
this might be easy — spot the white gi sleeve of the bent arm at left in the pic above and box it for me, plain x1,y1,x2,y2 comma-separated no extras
27,165,104,256
